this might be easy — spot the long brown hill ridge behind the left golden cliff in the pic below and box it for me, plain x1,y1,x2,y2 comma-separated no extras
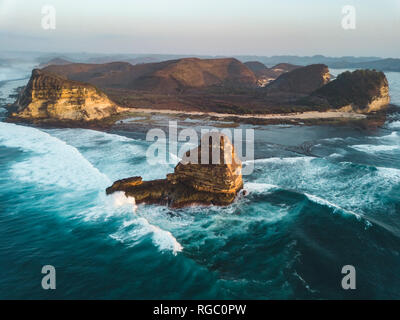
44,58,256,93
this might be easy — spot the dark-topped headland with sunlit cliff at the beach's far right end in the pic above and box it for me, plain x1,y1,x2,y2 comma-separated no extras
308,70,390,113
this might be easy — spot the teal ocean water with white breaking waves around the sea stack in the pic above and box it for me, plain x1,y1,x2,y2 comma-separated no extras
0,67,400,299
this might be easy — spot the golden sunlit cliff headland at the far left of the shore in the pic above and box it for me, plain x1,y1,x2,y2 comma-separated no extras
9,69,124,122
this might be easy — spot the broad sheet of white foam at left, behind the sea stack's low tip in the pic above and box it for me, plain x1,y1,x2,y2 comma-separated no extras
0,122,111,190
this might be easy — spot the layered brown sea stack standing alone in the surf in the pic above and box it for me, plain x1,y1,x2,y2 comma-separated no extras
106,133,243,208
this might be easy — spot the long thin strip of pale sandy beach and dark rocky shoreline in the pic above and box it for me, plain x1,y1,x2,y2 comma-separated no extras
3,108,390,131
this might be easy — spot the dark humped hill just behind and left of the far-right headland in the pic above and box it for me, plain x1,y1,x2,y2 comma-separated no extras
265,64,330,94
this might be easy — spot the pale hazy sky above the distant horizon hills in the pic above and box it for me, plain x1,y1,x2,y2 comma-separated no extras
0,0,400,57
